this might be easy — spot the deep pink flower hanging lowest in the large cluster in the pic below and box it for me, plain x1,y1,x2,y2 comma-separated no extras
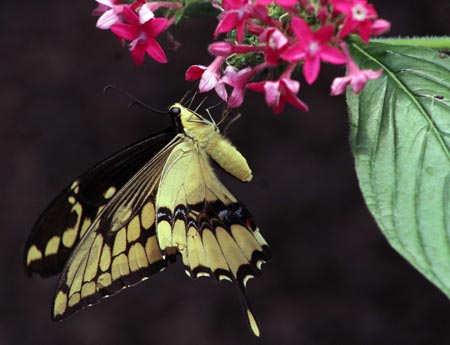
247,64,308,114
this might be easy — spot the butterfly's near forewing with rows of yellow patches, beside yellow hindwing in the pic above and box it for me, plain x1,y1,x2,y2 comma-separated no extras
52,137,185,320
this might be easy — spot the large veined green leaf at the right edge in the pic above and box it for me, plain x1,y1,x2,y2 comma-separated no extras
347,42,450,297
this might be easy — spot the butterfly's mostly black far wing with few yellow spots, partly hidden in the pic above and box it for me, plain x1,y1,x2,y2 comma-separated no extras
24,130,176,277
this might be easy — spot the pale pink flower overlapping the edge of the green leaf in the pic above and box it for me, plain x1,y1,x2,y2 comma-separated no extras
331,57,383,96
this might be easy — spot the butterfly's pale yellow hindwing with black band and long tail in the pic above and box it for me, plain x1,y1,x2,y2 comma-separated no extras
156,139,270,336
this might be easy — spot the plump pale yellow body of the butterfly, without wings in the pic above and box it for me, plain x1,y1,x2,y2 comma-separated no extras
173,103,253,182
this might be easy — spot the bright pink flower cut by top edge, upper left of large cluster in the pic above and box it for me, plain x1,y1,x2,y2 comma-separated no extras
214,0,269,43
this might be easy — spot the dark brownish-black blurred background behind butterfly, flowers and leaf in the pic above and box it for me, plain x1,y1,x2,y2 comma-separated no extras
0,0,450,345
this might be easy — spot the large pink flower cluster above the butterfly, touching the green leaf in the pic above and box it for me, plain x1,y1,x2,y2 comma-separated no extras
186,0,390,113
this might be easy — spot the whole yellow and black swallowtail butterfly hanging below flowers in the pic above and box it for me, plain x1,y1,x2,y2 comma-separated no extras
25,97,271,336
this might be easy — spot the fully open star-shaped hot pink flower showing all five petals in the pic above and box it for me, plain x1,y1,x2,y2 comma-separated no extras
281,17,346,84
